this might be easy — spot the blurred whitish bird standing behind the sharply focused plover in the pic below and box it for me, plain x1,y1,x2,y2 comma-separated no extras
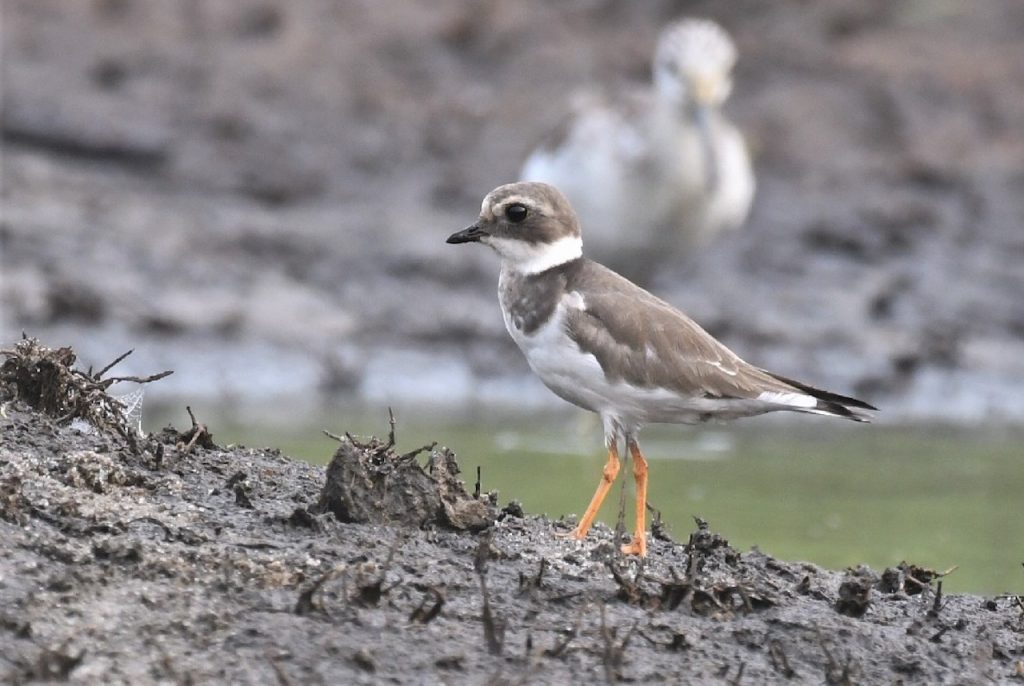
519,18,755,278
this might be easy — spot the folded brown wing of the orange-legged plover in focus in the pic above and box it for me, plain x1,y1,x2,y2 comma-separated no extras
567,262,796,398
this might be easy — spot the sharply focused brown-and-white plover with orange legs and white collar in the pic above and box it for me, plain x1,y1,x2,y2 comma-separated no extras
447,182,876,555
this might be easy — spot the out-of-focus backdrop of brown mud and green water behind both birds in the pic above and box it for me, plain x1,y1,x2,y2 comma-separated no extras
0,0,1024,591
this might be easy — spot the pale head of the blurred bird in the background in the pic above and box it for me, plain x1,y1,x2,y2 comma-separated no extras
653,19,736,112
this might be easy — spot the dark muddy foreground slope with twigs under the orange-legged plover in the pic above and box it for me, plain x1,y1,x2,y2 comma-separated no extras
6,344,1024,684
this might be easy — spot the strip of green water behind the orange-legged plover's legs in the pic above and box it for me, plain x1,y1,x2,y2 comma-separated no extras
203,413,1024,594
